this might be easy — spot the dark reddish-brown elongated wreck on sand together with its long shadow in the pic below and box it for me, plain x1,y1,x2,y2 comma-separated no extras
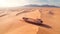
23,17,51,28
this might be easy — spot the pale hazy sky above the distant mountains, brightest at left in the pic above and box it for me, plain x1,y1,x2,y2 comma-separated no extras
0,0,60,7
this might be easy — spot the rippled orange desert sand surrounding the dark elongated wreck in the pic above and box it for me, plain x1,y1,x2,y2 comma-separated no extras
0,7,60,34
